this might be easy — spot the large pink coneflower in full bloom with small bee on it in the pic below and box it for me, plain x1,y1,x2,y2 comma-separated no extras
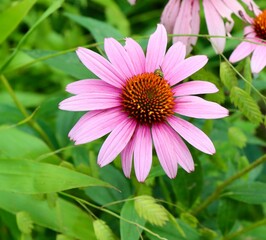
60,24,228,182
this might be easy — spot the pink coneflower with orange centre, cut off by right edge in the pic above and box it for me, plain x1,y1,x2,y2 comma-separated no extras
229,10,266,73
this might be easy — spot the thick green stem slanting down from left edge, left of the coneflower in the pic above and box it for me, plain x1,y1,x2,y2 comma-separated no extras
0,75,55,150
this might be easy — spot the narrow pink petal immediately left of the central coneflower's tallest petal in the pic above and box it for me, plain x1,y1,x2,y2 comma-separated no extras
125,38,145,74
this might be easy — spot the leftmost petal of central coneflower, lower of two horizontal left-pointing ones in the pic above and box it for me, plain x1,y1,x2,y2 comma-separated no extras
59,91,121,111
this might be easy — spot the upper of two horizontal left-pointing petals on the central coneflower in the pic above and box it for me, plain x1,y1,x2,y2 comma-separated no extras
66,79,120,94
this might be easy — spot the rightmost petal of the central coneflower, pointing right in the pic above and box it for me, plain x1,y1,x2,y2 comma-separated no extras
174,96,228,119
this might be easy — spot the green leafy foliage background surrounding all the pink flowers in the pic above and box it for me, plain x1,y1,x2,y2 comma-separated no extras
0,0,266,240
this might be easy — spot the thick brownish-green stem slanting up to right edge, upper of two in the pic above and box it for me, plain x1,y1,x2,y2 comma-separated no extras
192,154,266,215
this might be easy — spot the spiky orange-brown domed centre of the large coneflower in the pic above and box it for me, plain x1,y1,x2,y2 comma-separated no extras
122,73,175,125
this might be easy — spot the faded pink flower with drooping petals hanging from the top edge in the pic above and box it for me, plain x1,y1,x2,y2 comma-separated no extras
161,0,258,54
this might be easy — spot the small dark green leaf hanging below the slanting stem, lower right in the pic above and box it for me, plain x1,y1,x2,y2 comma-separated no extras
217,199,238,235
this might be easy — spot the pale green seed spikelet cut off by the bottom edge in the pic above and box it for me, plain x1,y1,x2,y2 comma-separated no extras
93,219,115,240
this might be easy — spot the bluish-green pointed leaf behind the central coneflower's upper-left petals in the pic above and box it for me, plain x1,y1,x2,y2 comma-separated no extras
65,13,123,43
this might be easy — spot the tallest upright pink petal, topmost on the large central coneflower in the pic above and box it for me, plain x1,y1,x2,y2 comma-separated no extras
145,24,167,72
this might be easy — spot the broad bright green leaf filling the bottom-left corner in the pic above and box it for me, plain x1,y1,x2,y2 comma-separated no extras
0,191,96,240
